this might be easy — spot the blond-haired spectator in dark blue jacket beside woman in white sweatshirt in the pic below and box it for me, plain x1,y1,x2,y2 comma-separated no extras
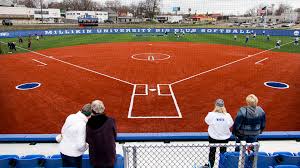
232,94,266,151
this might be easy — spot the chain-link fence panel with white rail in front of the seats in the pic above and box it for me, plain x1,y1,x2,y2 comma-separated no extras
123,142,259,168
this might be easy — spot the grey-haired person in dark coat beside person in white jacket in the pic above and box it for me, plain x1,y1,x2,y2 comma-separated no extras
86,100,117,168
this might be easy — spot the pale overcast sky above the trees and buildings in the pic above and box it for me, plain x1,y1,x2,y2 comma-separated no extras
52,0,300,14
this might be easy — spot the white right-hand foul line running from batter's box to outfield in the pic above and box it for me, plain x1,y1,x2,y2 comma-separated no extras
170,41,293,85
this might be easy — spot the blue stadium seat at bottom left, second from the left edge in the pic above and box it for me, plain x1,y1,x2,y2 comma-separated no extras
16,155,45,168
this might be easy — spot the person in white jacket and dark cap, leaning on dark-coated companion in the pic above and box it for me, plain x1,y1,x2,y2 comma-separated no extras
56,104,92,168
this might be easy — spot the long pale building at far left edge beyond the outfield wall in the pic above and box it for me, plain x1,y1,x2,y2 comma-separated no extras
0,6,62,24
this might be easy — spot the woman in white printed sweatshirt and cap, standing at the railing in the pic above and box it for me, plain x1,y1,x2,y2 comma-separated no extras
205,99,233,167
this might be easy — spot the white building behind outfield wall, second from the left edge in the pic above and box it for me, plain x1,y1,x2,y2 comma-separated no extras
66,11,108,23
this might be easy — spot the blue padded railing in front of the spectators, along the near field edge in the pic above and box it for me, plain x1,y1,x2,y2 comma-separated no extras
0,131,300,142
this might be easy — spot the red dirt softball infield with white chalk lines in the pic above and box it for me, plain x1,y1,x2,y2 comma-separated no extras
0,42,300,134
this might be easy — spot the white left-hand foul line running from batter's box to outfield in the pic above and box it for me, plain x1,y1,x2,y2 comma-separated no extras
0,41,134,85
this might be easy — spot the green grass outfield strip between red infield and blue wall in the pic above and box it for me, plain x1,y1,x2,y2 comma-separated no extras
1,34,300,54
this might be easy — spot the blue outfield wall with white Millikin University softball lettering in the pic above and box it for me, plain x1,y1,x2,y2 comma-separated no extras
0,28,300,38
